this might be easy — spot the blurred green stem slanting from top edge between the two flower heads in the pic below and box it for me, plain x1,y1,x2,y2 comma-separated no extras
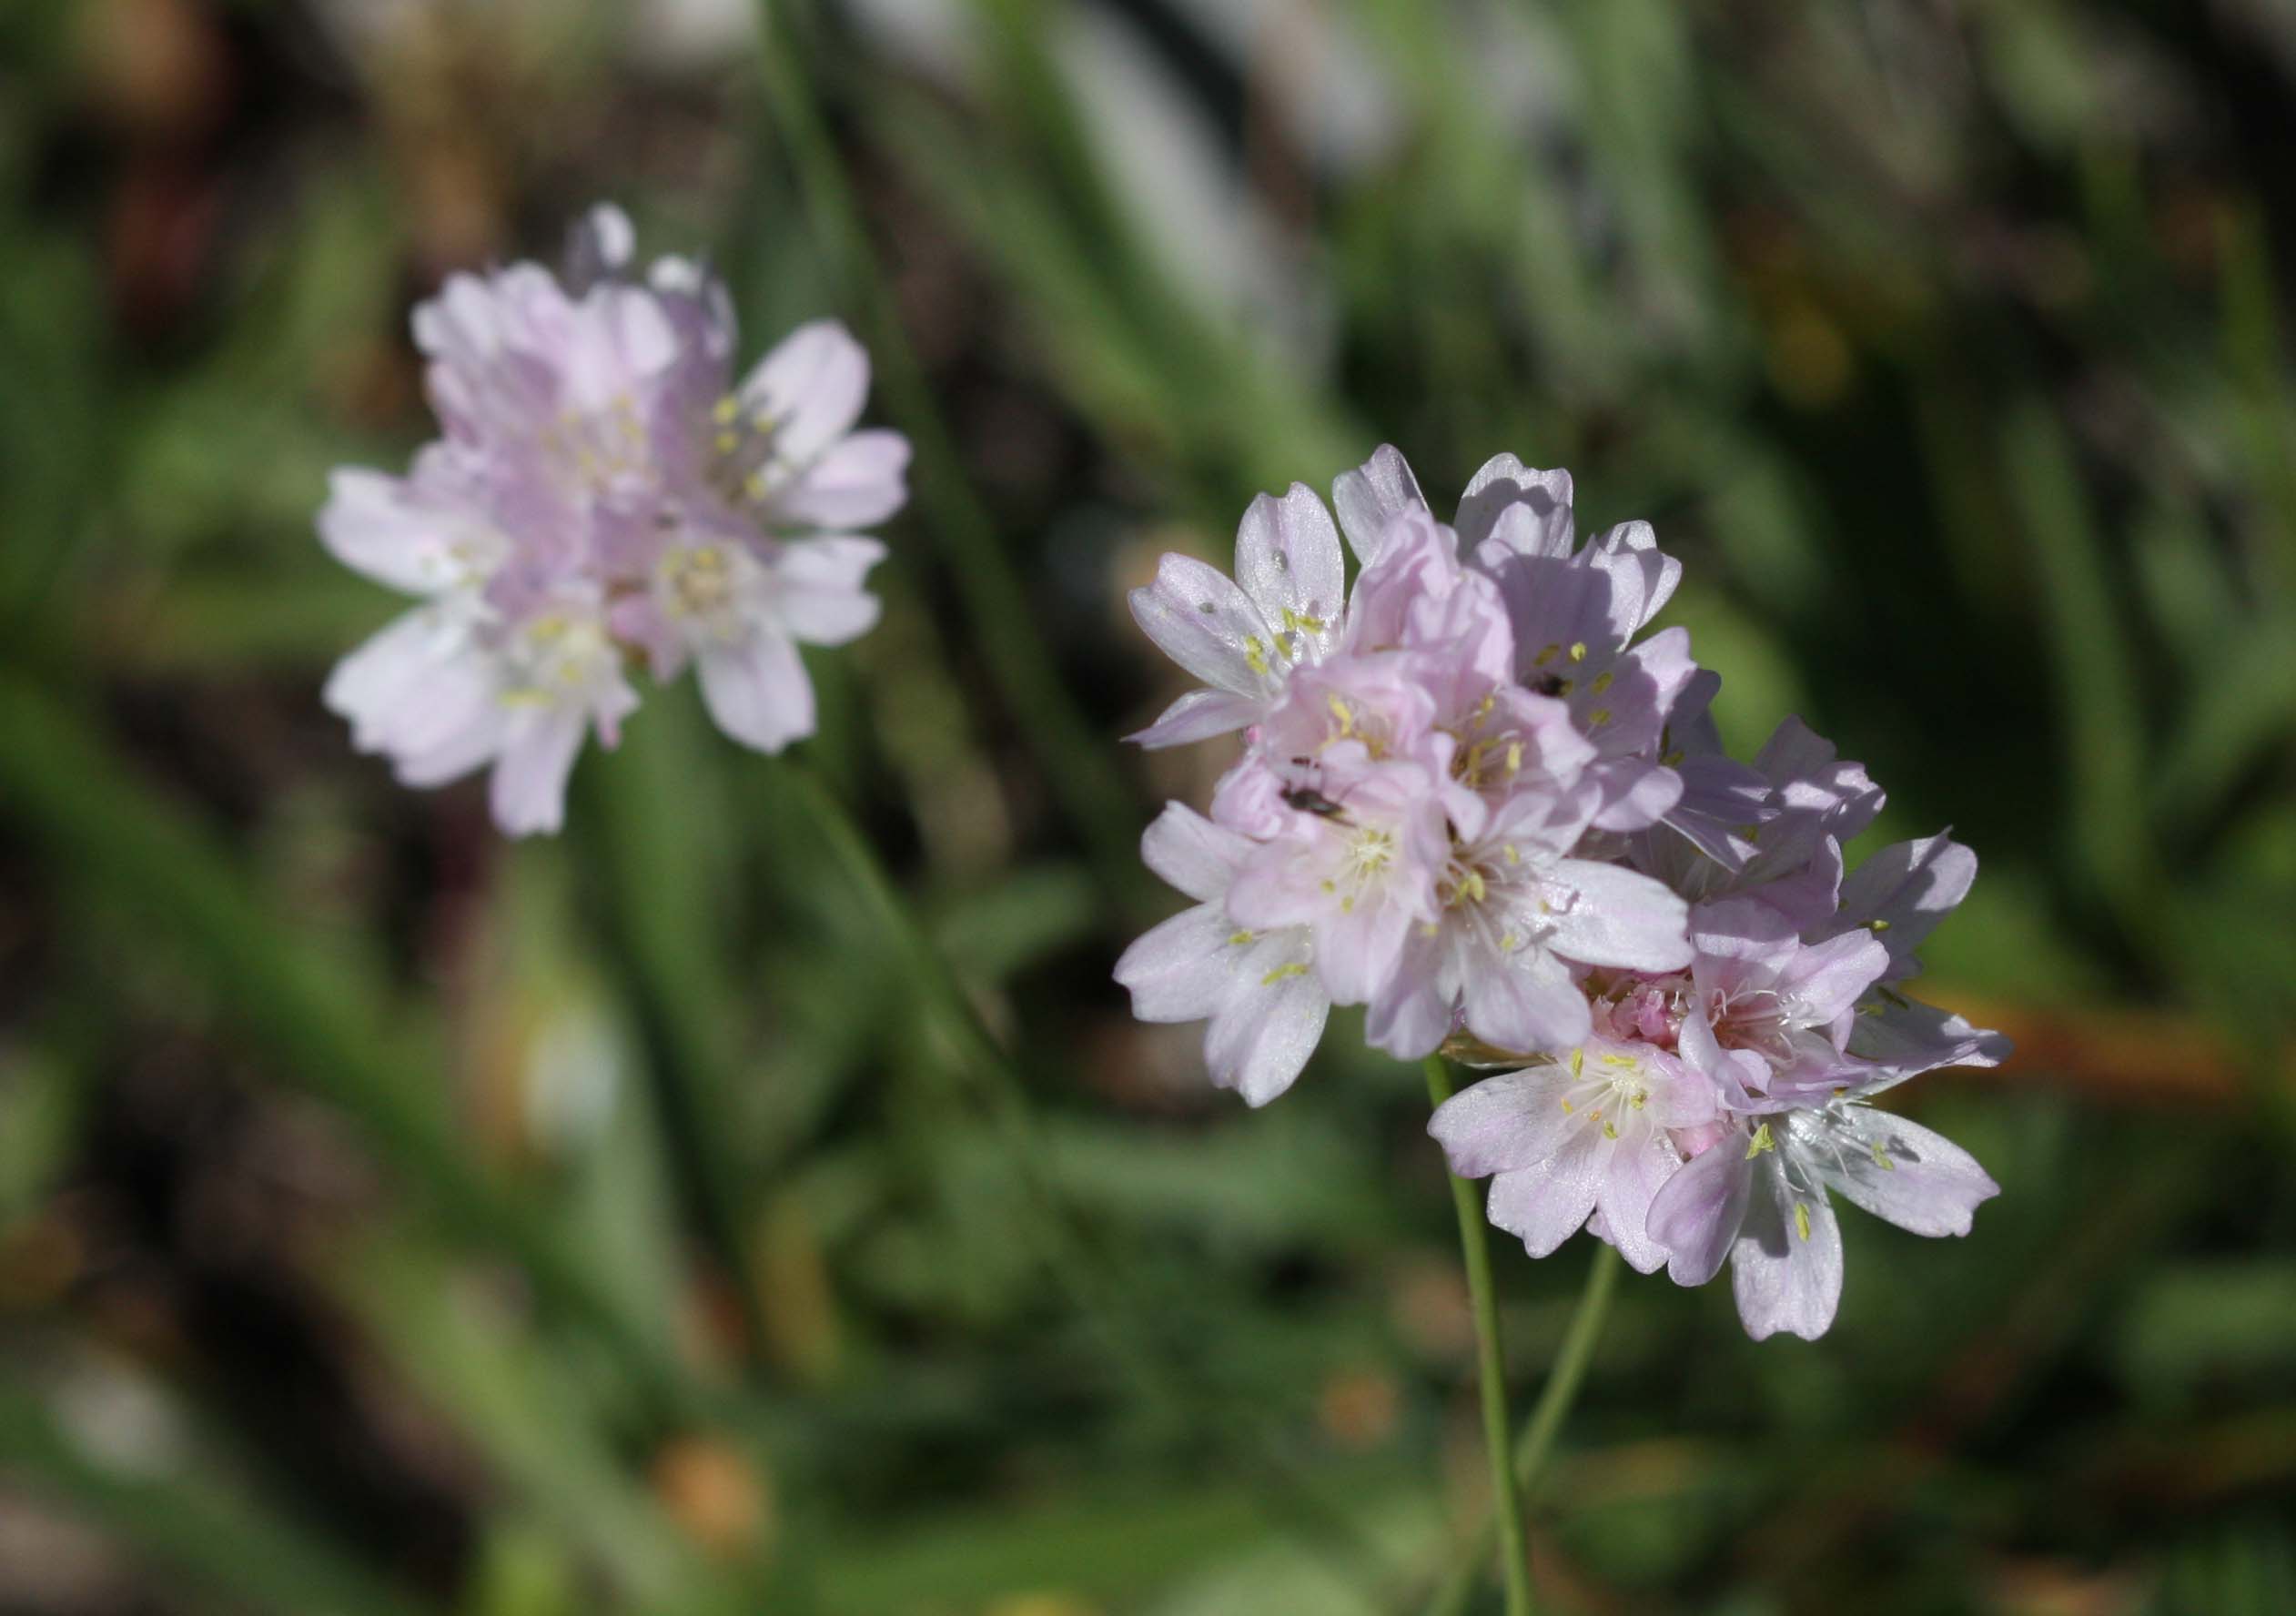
760,5,1146,906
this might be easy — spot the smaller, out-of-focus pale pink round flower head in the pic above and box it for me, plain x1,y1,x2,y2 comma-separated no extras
319,207,909,835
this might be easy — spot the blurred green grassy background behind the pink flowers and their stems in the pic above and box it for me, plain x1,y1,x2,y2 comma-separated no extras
0,0,2296,1616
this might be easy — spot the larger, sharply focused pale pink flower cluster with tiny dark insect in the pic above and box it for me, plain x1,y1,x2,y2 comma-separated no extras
1116,448,2007,1338
